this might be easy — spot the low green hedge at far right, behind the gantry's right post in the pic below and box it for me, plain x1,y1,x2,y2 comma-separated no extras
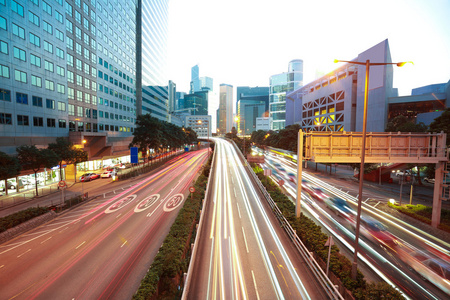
388,203,450,232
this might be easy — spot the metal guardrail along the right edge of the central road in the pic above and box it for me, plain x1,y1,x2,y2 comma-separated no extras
231,141,344,300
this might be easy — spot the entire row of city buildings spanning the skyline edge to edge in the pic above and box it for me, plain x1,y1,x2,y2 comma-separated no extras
0,0,450,178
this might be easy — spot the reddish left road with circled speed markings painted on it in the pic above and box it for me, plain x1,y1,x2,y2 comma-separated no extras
0,150,207,299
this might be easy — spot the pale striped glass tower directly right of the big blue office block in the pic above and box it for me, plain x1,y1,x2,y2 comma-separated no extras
136,0,173,121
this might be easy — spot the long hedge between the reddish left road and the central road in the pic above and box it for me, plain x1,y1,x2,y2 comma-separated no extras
133,156,212,299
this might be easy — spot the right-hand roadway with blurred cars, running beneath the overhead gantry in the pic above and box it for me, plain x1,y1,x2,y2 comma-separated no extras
264,157,450,299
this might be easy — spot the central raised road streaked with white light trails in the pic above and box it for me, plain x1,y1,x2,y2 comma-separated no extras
183,139,326,299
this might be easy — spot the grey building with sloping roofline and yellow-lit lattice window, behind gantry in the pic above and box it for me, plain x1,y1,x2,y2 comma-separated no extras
286,40,396,132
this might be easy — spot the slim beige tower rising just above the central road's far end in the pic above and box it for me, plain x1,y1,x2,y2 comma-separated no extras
217,83,234,134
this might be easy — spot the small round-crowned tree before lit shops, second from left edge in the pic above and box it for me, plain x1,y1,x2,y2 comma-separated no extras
16,145,59,196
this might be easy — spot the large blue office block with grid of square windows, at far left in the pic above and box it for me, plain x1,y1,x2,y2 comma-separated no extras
0,0,136,158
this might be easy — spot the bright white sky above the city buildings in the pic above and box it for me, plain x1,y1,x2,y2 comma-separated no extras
168,0,450,129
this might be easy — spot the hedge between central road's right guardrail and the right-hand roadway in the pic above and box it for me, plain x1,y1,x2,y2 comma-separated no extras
254,168,403,299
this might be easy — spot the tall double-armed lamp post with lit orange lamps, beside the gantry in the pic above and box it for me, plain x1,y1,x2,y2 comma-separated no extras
334,59,412,280
